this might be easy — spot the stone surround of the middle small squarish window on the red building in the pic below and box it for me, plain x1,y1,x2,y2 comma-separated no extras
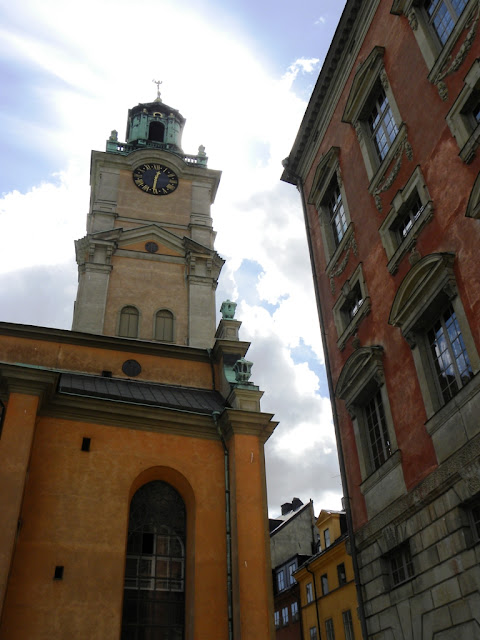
379,165,433,274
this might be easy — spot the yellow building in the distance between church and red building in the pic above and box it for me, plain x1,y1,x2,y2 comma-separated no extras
295,510,362,640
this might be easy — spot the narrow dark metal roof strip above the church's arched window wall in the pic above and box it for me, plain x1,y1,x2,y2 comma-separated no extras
58,373,225,415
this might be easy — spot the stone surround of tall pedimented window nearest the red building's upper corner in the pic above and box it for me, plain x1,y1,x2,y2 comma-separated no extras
307,147,353,271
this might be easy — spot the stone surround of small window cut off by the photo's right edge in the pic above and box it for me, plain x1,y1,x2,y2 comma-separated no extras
446,58,480,164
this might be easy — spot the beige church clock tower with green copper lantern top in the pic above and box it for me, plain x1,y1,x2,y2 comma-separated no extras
72,93,224,348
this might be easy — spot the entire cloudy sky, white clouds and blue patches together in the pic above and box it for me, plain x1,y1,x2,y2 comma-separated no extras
0,0,345,516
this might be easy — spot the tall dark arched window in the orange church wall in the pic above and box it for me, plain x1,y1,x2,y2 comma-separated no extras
121,481,186,640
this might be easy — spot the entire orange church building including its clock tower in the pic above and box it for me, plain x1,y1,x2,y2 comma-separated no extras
0,93,276,640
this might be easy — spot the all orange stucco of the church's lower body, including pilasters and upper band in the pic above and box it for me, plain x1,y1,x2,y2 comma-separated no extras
0,325,272,640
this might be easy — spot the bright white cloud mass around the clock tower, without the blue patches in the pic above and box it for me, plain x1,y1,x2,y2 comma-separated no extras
0,0,339,507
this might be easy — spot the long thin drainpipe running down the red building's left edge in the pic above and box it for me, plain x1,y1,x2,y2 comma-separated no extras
290,173,368,640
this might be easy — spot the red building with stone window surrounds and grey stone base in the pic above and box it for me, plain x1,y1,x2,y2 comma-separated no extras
282,0,480,639
